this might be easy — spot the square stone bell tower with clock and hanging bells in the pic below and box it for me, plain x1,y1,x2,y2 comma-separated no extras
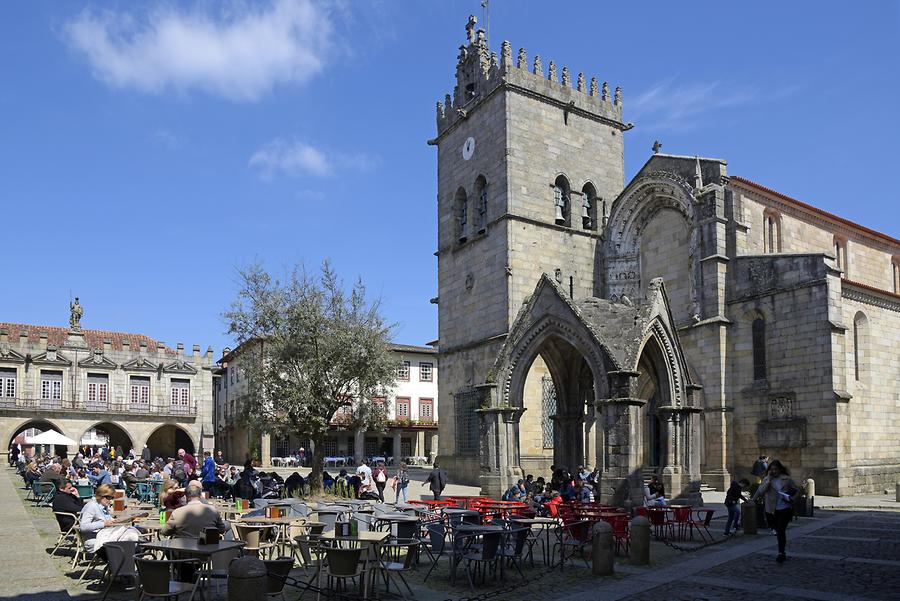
429,16,631,484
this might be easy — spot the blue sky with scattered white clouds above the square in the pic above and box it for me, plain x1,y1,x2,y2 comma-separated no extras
0,0,900,356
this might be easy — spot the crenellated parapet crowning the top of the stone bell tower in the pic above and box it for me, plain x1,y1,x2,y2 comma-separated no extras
437,16,631,134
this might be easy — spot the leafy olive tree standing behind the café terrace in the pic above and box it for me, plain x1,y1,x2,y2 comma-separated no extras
225,261,397,491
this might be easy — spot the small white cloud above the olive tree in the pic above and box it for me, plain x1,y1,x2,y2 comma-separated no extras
249,138,378,178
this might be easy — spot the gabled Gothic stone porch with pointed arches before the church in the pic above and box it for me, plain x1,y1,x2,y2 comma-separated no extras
476,275,699,502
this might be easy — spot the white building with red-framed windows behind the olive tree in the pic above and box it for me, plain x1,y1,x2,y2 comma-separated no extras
214,344,438,465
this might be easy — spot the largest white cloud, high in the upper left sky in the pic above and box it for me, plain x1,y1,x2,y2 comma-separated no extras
65,0,333,102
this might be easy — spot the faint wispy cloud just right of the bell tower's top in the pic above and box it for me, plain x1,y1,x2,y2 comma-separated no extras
626,79,757,130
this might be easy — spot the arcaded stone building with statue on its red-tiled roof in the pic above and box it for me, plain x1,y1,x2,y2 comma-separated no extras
0,299,213,456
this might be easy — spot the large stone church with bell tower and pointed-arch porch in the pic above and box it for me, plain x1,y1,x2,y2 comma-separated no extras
428,17,900,503
